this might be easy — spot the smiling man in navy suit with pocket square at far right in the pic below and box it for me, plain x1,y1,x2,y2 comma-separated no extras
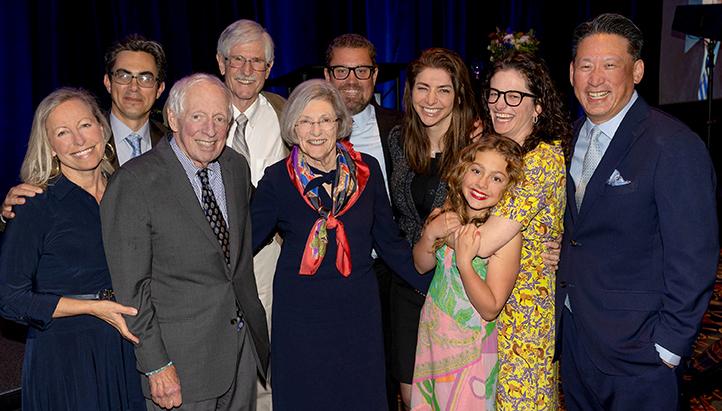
556,14,719,410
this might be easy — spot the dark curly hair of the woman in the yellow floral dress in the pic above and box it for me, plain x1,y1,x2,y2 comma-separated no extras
481,51,572,158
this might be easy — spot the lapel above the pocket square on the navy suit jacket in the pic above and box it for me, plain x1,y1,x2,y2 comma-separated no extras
579,97,649,218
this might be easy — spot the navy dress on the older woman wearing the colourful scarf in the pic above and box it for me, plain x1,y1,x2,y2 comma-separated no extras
251,155,425,411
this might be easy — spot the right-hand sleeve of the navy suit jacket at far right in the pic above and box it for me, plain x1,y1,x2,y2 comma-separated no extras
653,121,719,356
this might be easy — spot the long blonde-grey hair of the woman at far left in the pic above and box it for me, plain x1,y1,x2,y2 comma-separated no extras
20,87,113,187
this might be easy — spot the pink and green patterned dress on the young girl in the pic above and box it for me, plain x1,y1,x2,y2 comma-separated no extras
411,246,499,411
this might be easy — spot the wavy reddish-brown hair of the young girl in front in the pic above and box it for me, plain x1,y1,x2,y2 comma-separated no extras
426,133,524,249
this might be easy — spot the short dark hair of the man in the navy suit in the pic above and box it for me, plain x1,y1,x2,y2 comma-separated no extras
572,13,644,61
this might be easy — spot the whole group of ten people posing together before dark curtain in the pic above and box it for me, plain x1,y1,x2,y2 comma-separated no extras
0,14,719,410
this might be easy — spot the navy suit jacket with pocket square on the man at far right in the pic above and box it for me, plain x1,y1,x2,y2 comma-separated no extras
556,97,719,375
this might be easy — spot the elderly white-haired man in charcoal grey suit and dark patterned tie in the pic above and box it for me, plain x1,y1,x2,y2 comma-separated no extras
101,74,268,410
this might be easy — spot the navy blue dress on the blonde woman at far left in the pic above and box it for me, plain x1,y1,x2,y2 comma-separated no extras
0,176,145,410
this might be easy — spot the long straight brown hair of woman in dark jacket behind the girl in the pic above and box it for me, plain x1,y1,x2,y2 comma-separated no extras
401,48,477,174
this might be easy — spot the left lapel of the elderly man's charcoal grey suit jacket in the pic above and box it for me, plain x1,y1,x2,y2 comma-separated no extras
155,139,225,268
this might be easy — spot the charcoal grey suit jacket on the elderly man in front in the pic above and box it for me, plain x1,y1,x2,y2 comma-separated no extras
101,139,269,402
